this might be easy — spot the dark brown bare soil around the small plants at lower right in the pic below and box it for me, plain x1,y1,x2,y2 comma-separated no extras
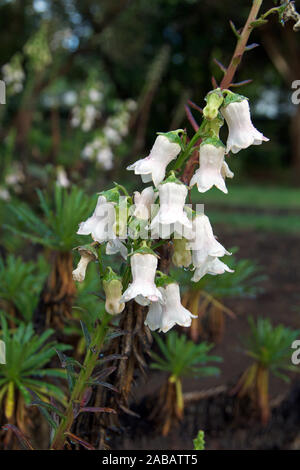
112,227,300,449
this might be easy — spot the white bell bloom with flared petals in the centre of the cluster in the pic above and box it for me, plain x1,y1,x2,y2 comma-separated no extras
151,182,192,238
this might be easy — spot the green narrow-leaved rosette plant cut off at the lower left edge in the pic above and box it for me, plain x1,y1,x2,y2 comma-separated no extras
0,316,70,448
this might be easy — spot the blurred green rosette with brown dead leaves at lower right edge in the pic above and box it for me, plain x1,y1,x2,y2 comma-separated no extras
232,318,300,425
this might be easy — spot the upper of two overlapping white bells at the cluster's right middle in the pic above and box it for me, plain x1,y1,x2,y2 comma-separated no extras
188,214,230,268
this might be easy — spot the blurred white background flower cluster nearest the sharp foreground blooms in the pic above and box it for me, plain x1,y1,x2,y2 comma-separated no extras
82,100,136,170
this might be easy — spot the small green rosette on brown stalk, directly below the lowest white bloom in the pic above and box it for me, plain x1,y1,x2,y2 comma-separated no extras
150,331,222,436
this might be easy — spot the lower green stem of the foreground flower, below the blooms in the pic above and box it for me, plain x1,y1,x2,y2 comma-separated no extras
51,313,111,450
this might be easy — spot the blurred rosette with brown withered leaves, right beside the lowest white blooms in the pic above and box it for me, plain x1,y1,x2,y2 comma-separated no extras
175,249,266,343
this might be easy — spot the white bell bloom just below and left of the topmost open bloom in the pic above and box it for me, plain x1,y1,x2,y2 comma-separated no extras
190,144,228,194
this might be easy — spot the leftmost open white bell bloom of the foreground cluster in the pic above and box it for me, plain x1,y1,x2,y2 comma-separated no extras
77,196,116,243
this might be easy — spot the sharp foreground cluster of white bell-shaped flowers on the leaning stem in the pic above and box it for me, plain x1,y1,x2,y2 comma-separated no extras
76,90,268,332
